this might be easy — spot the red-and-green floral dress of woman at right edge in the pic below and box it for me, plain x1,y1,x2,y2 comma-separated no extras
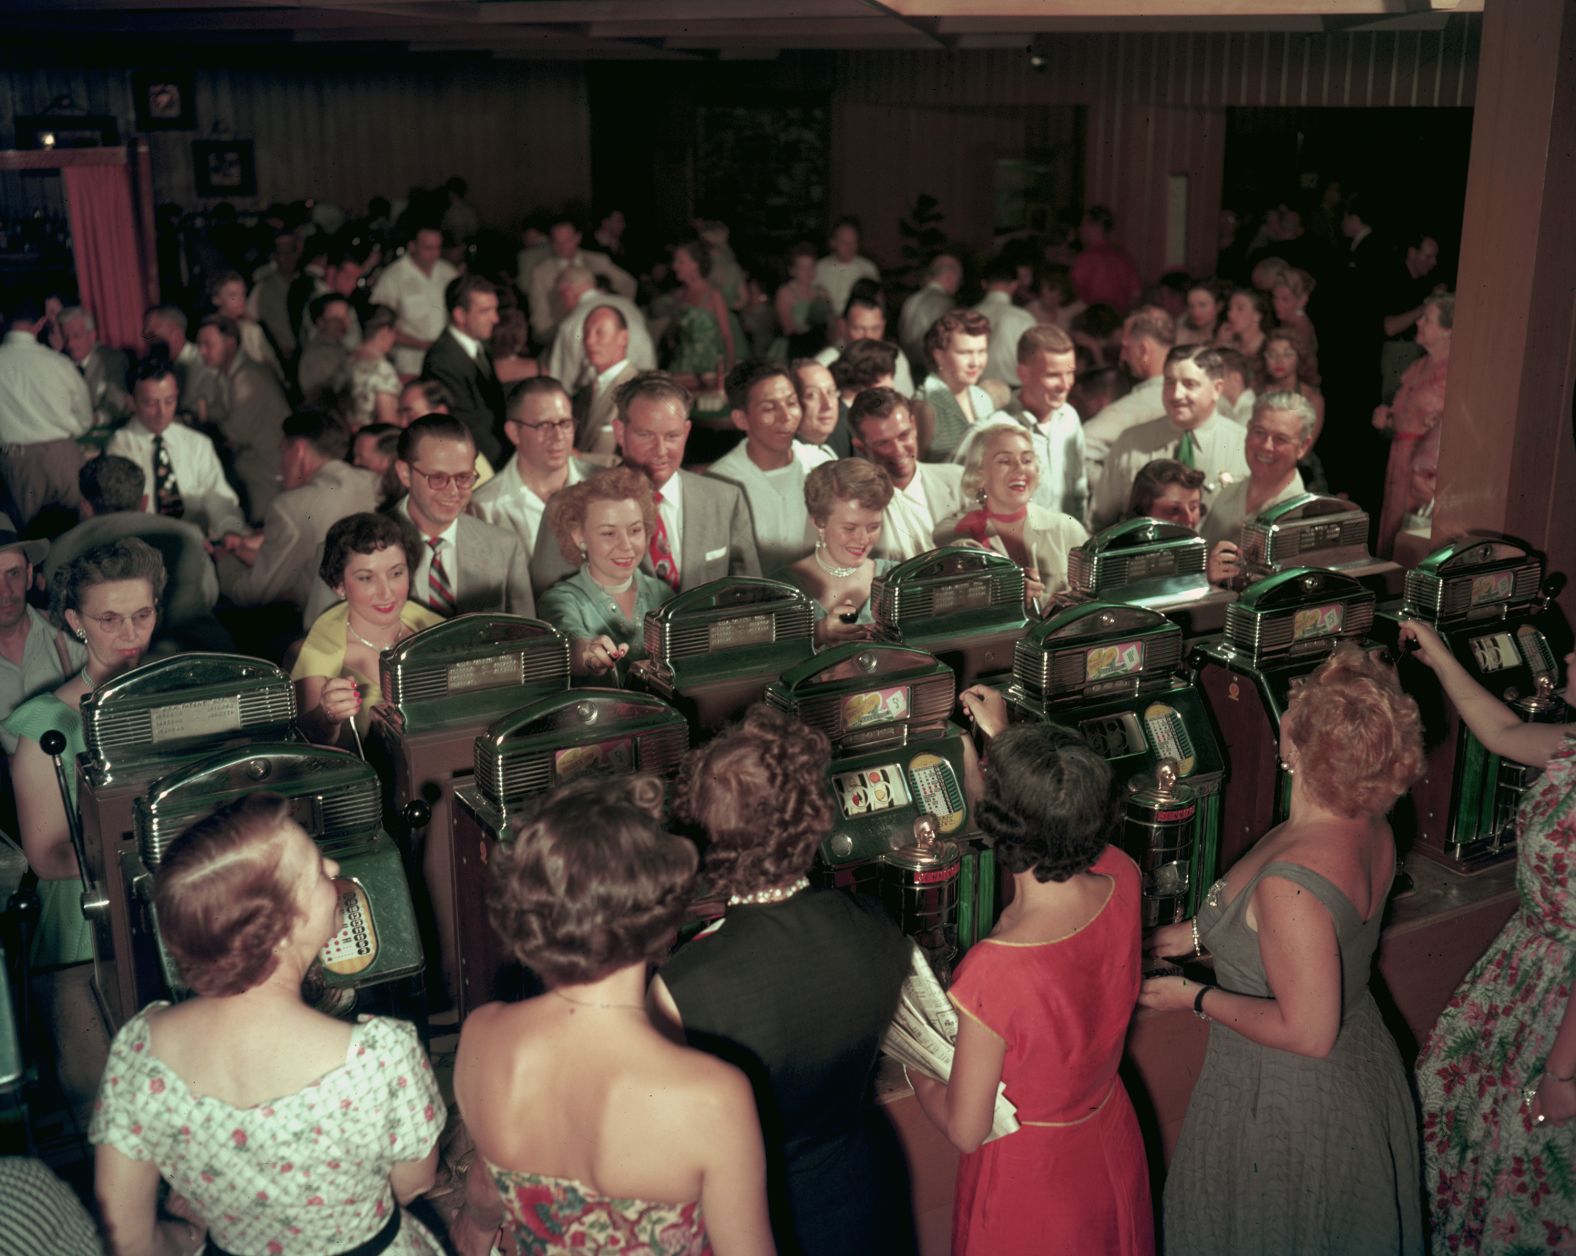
1417,738,1576,1256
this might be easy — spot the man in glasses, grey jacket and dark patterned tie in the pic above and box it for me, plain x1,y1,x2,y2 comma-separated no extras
389,414,536,618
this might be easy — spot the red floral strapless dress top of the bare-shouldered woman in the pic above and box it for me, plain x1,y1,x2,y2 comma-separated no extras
487,1163,711,1256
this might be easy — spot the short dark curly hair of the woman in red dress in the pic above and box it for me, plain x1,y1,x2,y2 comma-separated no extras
974,723,1121,883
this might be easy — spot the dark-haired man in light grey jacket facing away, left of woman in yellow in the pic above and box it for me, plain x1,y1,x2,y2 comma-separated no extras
219,410,378,610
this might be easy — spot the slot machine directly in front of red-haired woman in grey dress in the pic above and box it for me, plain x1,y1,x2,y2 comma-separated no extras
1190,567,1379,870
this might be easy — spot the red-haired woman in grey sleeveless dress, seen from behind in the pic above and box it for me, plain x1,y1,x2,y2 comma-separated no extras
1139,646,1423,1253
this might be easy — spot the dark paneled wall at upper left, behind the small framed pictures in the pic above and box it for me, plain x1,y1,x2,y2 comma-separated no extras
0,61,591,225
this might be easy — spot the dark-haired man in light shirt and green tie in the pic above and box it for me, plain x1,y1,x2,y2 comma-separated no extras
1089,345,1248,531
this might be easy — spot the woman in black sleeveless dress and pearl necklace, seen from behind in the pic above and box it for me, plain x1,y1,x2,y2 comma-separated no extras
651,704,913,1256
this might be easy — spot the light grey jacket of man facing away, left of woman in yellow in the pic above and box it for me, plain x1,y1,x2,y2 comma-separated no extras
219,459,378,608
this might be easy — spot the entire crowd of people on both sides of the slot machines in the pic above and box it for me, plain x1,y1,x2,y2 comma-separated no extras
0,184,1576,1256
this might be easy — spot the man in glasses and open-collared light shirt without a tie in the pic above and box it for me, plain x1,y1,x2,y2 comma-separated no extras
470,375,596,567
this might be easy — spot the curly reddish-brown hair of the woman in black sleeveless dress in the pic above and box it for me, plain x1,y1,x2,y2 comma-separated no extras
675,703,835,894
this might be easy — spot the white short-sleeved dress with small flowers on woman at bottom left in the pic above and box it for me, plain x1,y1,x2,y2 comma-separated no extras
88,1004,446,1256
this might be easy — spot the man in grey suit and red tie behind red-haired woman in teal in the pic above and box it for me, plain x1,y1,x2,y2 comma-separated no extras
531,370,761,591
